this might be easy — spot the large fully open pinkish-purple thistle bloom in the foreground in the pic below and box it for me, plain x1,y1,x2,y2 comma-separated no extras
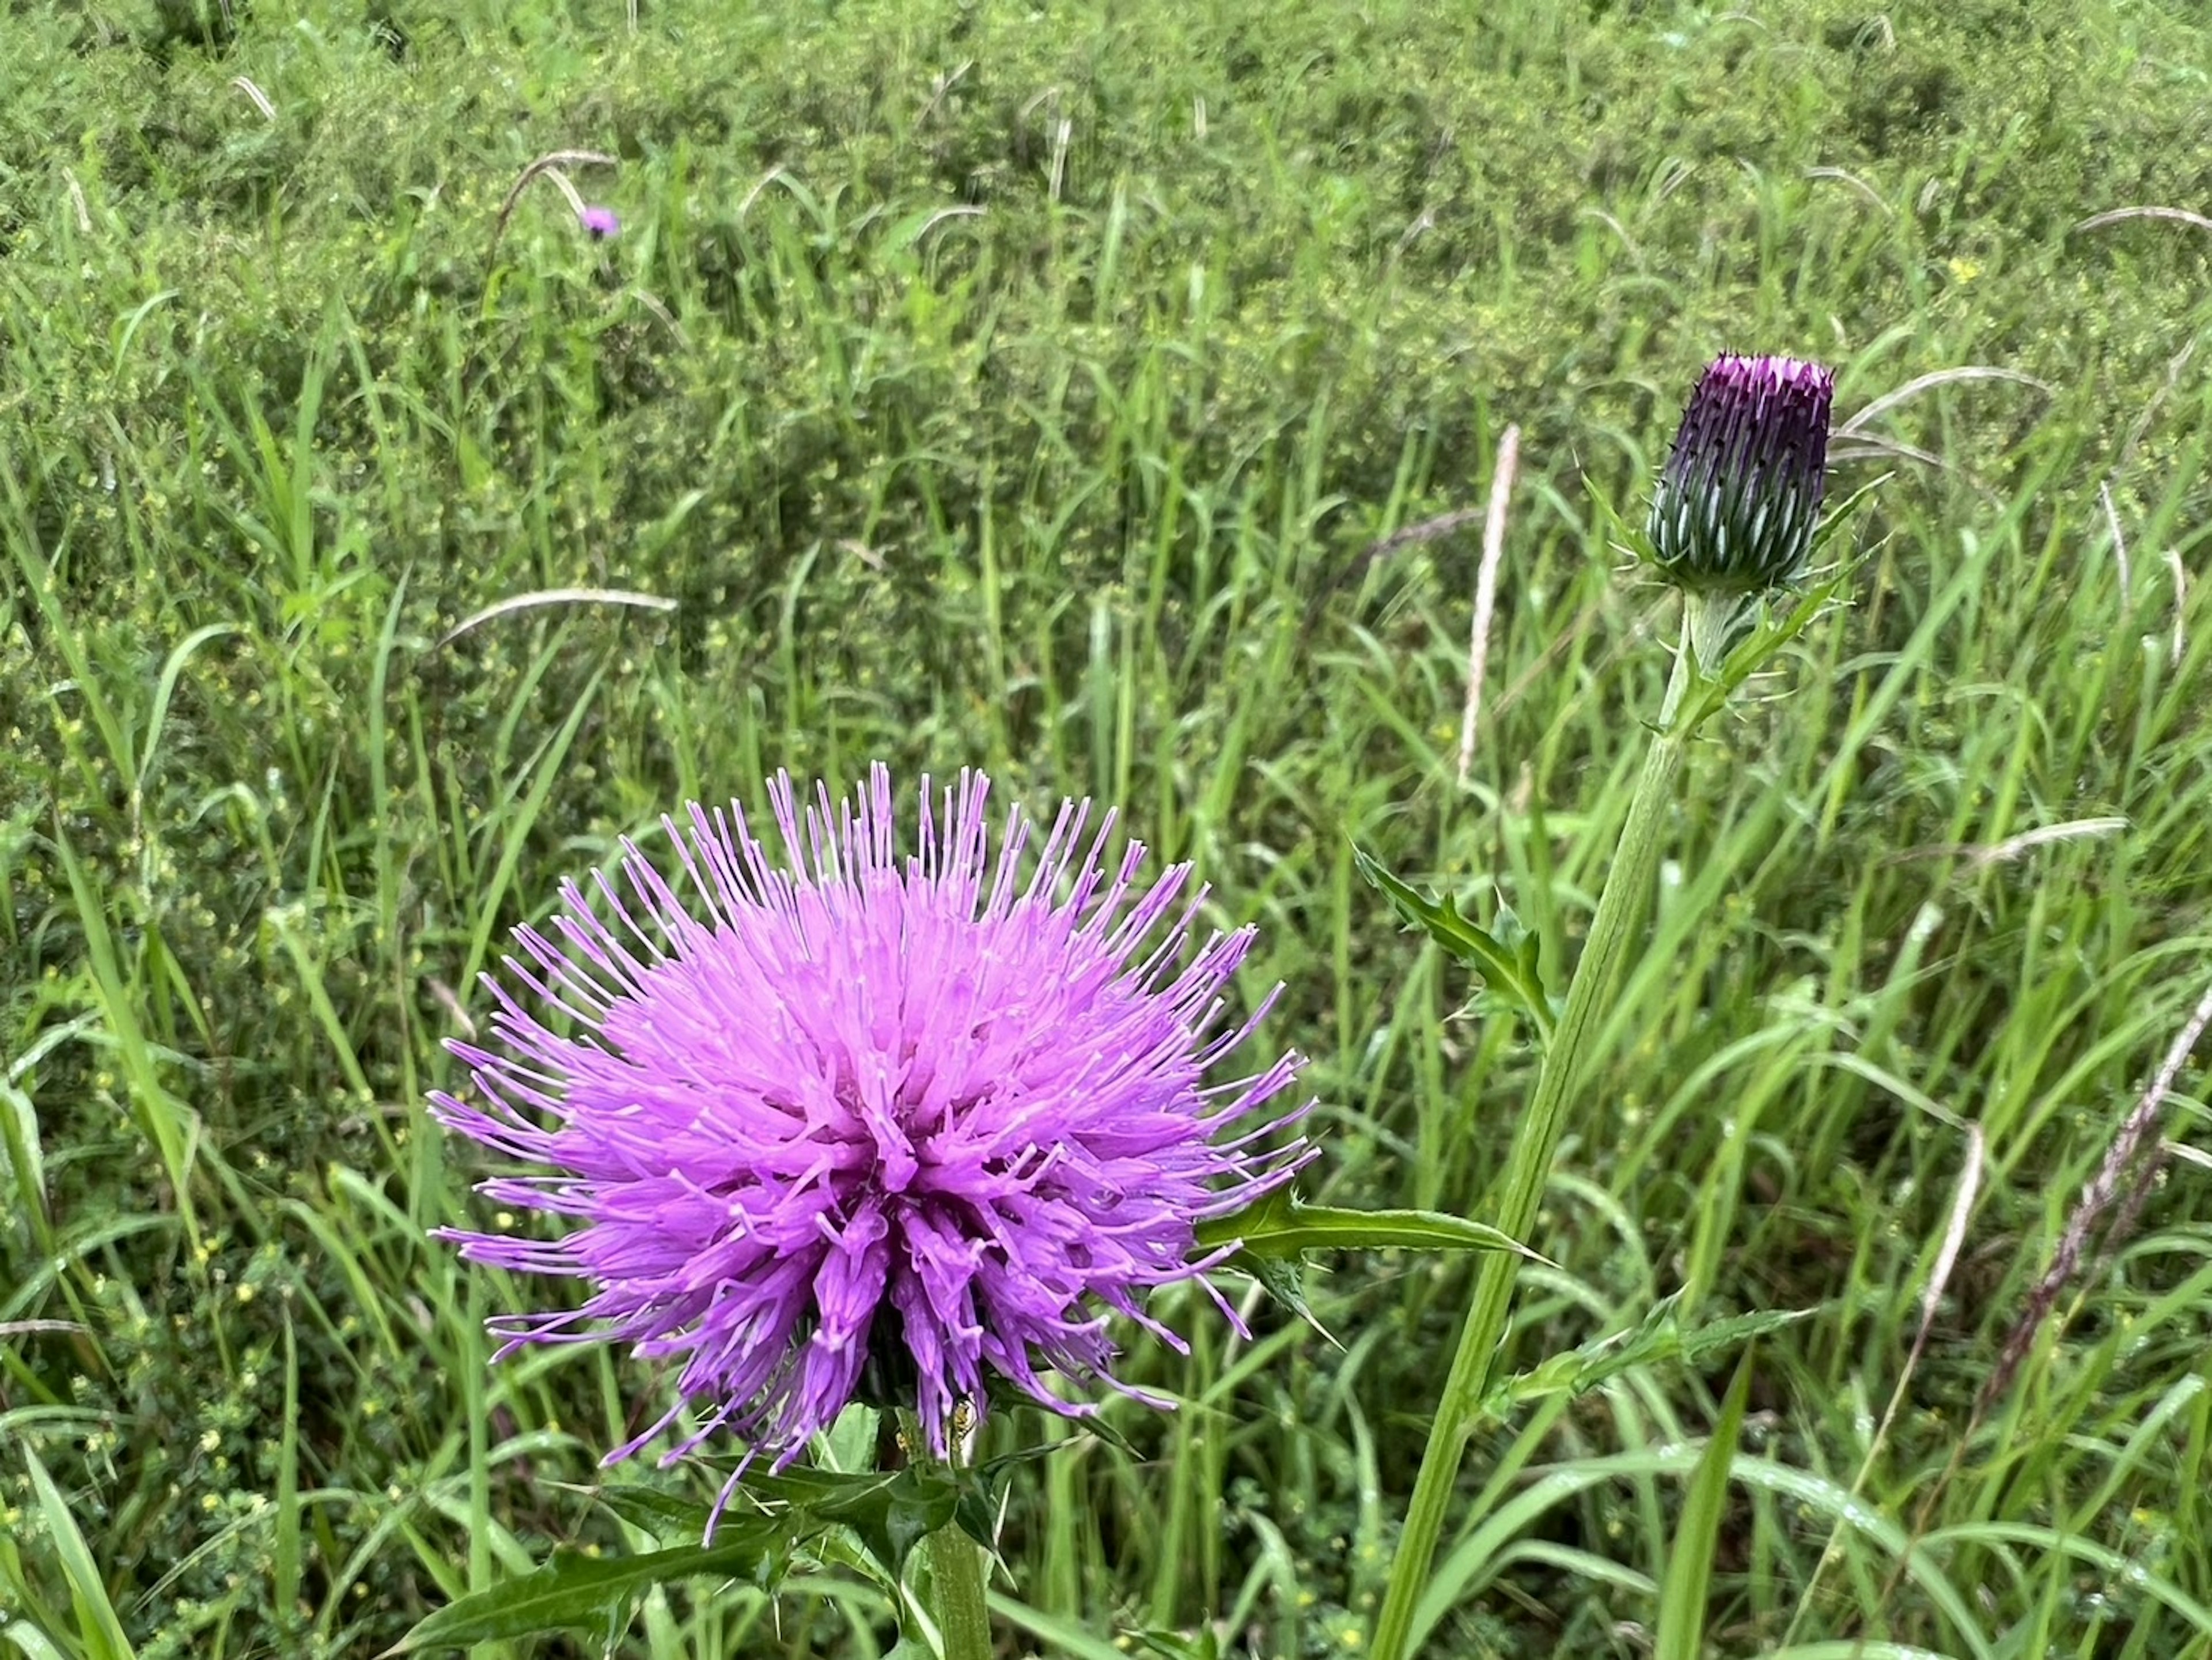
431,766,1314,1494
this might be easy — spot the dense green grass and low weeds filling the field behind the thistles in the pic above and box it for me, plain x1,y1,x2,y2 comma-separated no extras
13,0,2212,1660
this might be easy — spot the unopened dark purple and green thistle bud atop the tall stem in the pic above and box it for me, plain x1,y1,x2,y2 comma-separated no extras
1643,354,1836,593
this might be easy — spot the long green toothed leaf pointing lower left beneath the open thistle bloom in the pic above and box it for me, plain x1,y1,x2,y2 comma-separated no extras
385,1521,783,1655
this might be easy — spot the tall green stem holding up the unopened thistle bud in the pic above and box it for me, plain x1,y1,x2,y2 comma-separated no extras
1372,593,1707,1660
